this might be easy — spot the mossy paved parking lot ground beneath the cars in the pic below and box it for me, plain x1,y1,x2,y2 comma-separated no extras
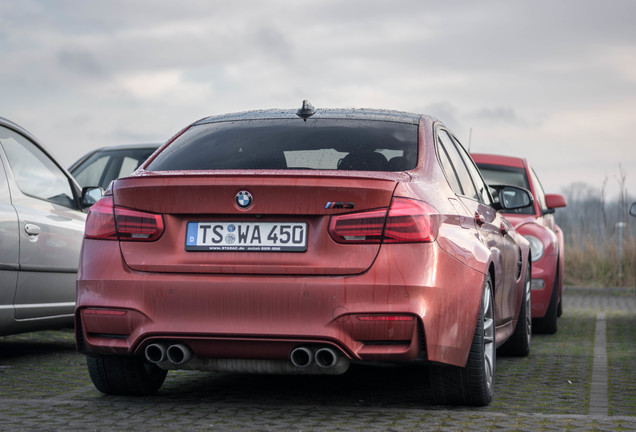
0,288,636,431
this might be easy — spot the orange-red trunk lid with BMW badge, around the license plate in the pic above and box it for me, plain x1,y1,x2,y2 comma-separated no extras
113,171,402,275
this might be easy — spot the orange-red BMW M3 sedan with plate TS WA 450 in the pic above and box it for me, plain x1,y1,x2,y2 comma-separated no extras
75,101,532,405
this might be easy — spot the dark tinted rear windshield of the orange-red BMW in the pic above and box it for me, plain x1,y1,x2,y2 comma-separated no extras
146,119,418,171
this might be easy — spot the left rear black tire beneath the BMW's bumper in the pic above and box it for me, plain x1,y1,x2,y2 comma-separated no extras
86,355,168,396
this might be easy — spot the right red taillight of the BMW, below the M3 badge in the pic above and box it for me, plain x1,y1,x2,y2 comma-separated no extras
329,198,439,243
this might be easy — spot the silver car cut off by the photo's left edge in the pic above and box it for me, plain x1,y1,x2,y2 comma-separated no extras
0,117,86,335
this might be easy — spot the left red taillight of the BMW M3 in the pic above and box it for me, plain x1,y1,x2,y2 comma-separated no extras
84,196,164,241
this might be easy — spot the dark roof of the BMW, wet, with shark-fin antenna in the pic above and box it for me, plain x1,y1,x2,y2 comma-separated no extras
194,108,434,125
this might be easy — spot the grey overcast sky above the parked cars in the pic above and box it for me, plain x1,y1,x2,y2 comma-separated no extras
0,0,636,200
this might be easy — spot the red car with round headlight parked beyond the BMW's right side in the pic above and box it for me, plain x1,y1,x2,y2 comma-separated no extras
471,153,566,333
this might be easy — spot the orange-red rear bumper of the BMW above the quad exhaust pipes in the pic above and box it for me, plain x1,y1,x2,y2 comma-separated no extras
75,240,484,366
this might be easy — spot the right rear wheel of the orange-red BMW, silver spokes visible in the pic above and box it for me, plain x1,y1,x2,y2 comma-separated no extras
429,276,497,406
